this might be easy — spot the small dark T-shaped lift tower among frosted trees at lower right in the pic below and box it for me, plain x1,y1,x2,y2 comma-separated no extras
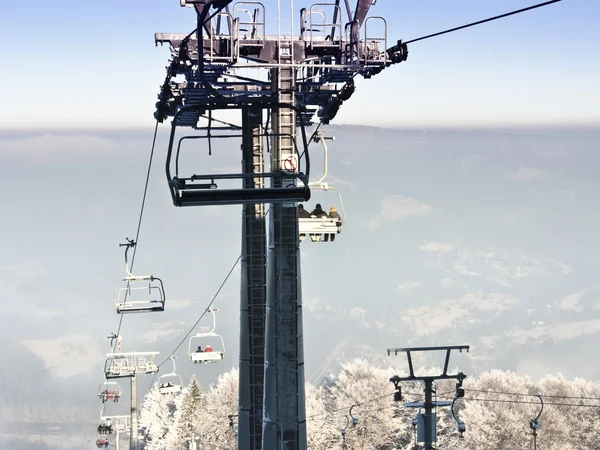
387,345,469,450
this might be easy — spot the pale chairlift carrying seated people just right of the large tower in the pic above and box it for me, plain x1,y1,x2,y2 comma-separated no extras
298,132,346,242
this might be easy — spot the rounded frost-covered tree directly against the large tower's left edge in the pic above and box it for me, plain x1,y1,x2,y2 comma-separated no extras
198,369,239,450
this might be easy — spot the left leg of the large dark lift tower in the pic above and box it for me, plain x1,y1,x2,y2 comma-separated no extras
238,107,267,450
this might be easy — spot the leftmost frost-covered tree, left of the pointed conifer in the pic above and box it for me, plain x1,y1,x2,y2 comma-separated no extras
140,384,176,450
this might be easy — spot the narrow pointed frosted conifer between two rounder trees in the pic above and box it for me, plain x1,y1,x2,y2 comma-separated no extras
167,376,204,450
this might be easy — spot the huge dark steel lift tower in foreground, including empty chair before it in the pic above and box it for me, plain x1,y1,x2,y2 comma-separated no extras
155,0,407,450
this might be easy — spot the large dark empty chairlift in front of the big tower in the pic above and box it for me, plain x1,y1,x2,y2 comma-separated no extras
166,98,310,206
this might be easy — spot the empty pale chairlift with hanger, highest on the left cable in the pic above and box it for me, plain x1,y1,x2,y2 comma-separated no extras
115,239,165,314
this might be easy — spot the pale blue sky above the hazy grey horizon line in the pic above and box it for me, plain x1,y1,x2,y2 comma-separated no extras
0,0,600,129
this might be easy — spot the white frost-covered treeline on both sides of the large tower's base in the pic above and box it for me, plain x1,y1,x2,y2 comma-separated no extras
134,359,600,450
